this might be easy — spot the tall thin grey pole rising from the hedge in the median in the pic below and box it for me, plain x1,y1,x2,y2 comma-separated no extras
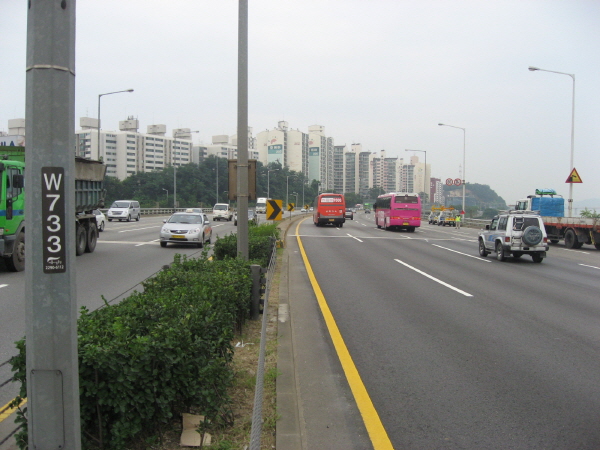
237,0,249,259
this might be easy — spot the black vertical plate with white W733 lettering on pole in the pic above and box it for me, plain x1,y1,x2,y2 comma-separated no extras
42,167,67,273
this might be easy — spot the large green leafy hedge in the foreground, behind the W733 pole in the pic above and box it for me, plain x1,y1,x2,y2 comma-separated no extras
11,257,252,449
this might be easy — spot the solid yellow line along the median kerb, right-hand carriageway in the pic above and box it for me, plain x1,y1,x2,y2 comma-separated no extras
296,219,394,450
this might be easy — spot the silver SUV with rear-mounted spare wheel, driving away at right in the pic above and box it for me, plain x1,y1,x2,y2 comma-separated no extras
479,210,548,263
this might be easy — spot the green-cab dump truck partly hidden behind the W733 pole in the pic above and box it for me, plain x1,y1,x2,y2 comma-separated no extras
0,146,106,272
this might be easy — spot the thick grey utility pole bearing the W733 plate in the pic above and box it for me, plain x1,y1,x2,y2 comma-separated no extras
25,0,81,450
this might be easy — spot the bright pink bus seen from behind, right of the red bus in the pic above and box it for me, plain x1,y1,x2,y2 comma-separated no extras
373,192,422,231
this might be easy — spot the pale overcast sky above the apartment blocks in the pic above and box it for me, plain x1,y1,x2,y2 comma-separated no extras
0,0,600,207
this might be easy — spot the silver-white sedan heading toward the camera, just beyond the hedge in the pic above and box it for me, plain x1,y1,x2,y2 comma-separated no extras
160,213,212,248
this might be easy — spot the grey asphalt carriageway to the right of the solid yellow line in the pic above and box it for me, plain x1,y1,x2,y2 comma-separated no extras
288,213,600,449
